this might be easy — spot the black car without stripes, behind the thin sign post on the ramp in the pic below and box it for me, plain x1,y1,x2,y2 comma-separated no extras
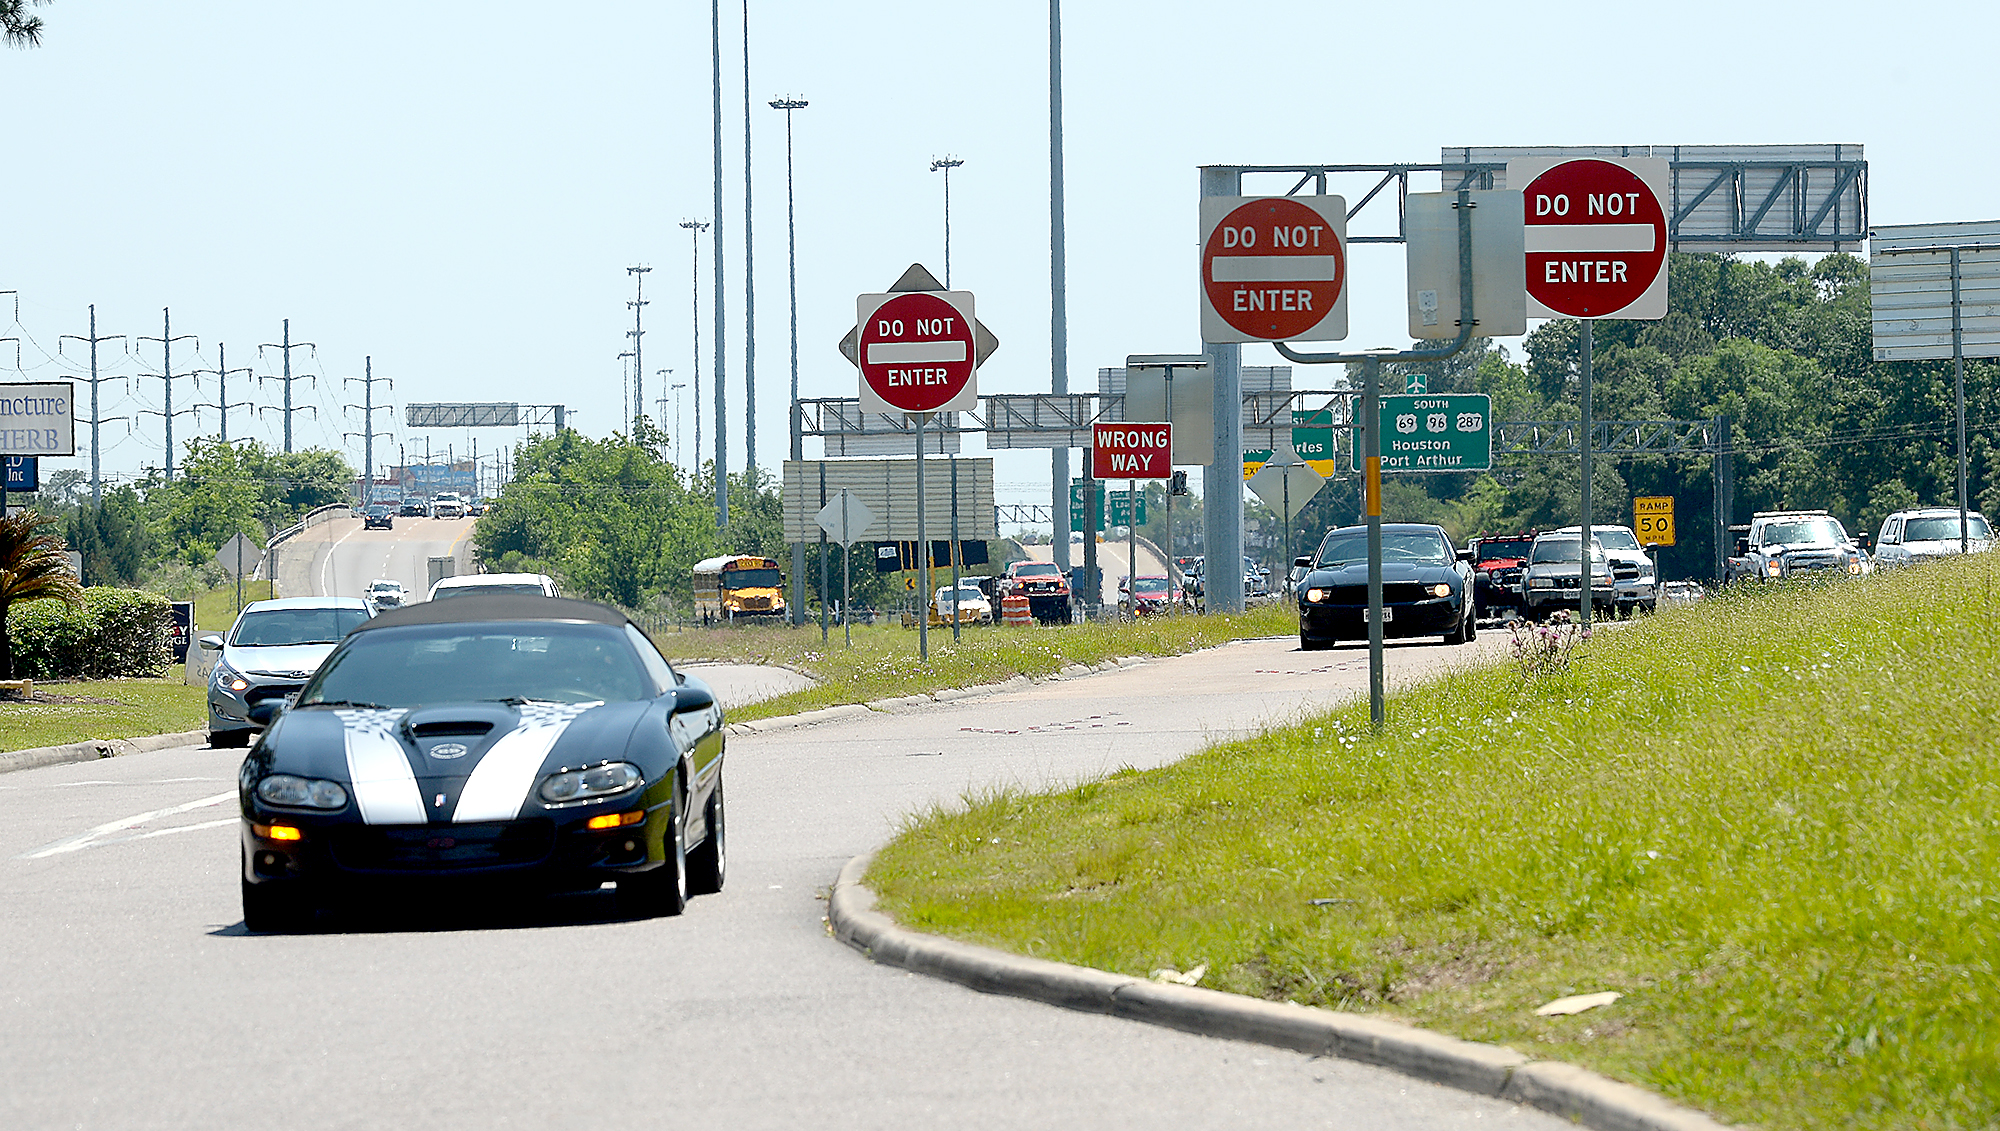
1298,522,1474,651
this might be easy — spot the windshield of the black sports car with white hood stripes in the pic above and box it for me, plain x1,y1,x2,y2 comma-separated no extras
298,621,654,707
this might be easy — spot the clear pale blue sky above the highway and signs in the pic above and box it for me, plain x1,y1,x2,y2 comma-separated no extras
0,0,2000,502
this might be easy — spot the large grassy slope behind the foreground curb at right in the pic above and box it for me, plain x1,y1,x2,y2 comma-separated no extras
870,554,2000,1129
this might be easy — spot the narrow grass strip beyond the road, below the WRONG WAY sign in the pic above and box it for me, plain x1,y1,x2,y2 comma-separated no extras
656,603,1298,721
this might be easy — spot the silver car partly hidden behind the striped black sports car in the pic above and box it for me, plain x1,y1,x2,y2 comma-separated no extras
200,597,374,747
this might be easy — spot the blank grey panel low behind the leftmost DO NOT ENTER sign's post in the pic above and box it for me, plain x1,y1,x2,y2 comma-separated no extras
784,460,1000,542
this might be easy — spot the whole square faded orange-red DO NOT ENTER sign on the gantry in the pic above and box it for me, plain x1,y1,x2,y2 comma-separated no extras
1202,196,1348,342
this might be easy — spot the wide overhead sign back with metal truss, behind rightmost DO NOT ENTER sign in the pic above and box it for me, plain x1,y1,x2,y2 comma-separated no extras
1442,144,1868,252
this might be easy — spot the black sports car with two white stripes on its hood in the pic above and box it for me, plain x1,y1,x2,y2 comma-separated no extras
238,593,728,931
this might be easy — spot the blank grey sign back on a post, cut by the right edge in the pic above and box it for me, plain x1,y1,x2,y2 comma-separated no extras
1868,220,2000,362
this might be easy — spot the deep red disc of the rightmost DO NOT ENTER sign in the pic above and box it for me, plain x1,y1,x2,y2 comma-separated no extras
1522,160,1666,318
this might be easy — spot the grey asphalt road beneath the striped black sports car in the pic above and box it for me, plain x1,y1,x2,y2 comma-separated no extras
0,635,1564,1131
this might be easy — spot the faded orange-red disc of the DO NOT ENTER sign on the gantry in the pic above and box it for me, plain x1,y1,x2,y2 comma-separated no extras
1202,196,1348,342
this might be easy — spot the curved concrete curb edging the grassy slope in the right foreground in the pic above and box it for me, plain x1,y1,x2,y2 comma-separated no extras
826,853,1724,1131
